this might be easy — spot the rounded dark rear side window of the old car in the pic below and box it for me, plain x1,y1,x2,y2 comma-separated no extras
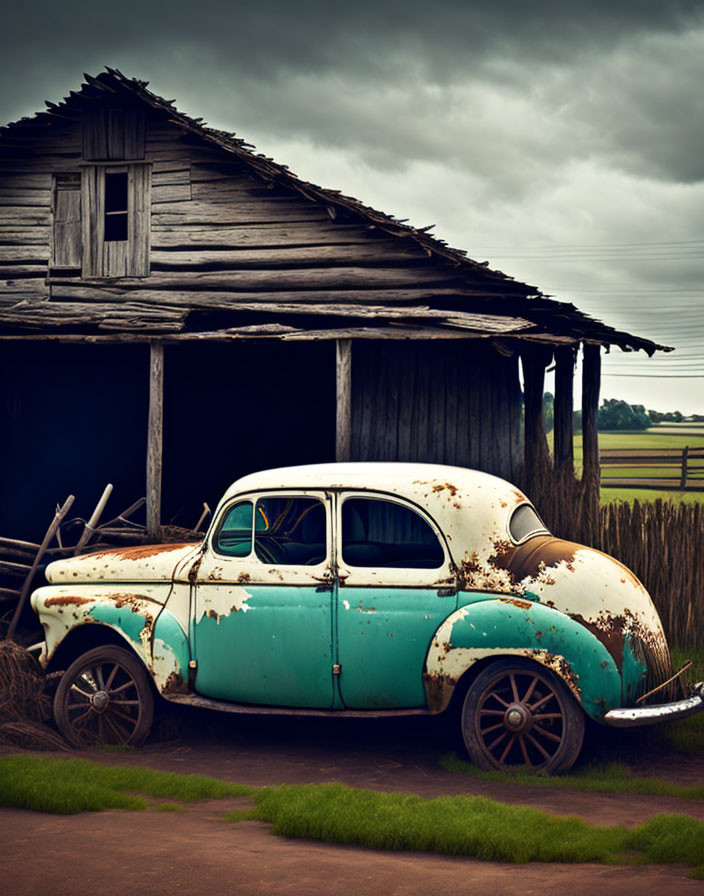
342,498,445,569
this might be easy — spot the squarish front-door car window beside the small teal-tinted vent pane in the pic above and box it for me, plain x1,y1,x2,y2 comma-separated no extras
254,495,327,566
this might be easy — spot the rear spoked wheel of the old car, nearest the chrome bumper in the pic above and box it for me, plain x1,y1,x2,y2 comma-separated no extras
462,658,584,774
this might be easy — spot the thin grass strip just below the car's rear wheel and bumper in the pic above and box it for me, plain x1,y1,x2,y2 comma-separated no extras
440,753,704,800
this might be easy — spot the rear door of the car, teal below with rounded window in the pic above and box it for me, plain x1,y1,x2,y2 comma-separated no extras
336,491,457,709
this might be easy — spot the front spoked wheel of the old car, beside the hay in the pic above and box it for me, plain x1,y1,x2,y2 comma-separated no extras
54,645,154,747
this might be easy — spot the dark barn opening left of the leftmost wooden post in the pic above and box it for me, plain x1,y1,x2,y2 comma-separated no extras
0,342,149,541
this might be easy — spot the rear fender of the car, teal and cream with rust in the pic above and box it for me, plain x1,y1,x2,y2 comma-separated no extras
423,597,621,720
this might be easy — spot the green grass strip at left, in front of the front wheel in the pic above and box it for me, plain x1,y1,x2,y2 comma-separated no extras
0,755,251,815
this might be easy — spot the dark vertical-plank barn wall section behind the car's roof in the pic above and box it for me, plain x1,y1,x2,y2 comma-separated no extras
352,342,522,480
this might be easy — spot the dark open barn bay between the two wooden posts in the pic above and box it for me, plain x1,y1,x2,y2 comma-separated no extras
161,341,335,527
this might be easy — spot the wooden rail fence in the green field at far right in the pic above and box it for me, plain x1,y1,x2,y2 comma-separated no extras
599,447,704,491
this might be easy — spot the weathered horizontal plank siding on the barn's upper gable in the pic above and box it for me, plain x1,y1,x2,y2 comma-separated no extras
0,102,466,316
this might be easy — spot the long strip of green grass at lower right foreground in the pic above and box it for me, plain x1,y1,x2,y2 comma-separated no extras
225,784,704,866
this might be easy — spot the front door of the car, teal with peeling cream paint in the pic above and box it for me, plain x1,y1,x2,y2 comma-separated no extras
191,491,333,708
